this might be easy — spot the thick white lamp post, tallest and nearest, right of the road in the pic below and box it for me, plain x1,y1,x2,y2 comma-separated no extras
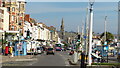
88,0,94,65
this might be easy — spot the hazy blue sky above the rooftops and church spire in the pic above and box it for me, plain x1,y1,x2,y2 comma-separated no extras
26,2,118,34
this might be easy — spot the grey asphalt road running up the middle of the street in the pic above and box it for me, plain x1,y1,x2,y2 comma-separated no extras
2,51,72,66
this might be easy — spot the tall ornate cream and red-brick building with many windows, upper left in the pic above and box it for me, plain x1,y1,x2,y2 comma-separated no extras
2,0,26,33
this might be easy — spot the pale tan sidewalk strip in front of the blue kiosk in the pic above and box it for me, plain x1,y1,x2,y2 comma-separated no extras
0,55,33,63
